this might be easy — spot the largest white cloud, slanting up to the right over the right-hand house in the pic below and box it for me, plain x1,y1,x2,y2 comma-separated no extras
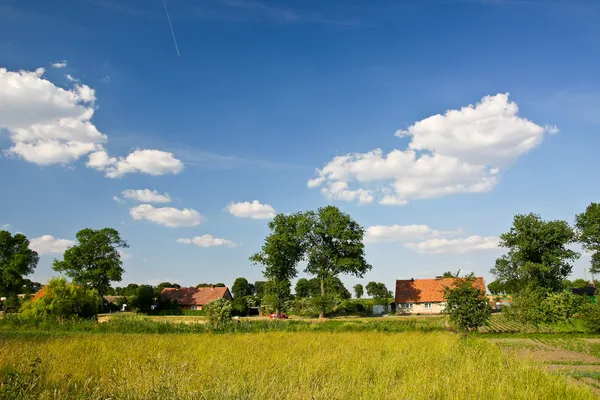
307,93,558,204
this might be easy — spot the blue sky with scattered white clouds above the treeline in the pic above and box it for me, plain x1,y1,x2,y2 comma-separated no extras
0,0,600,287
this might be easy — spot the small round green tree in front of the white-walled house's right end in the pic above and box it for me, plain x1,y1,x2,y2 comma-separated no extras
444,274,492,332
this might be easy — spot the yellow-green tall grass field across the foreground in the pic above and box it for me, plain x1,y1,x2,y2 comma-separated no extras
0,332,596,400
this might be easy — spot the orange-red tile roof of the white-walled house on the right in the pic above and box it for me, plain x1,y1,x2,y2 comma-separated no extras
396,277,485,303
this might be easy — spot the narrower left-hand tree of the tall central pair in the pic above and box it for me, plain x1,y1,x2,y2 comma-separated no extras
250,213,306,316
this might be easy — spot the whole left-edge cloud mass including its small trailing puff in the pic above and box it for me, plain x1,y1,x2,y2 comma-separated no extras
0,63,183,178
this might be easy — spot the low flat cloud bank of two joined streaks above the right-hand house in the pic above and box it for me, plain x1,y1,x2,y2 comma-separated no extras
365,225,499,254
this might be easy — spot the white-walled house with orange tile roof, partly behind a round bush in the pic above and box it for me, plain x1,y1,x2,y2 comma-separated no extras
396,276,485,314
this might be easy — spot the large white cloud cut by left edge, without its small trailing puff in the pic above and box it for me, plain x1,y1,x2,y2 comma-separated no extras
0,68,107,165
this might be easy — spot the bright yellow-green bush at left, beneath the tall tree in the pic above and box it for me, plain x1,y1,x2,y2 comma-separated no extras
20,278,101,319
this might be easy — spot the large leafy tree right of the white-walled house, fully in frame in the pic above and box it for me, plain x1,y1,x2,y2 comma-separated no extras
491,213,579,294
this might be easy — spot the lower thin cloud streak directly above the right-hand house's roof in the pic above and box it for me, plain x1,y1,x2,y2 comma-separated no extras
405,236,499,254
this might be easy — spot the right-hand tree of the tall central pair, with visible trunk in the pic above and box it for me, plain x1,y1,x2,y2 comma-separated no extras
306,206,372,318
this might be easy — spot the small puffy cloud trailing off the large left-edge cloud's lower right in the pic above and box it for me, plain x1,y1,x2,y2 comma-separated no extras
87,149,184,178
